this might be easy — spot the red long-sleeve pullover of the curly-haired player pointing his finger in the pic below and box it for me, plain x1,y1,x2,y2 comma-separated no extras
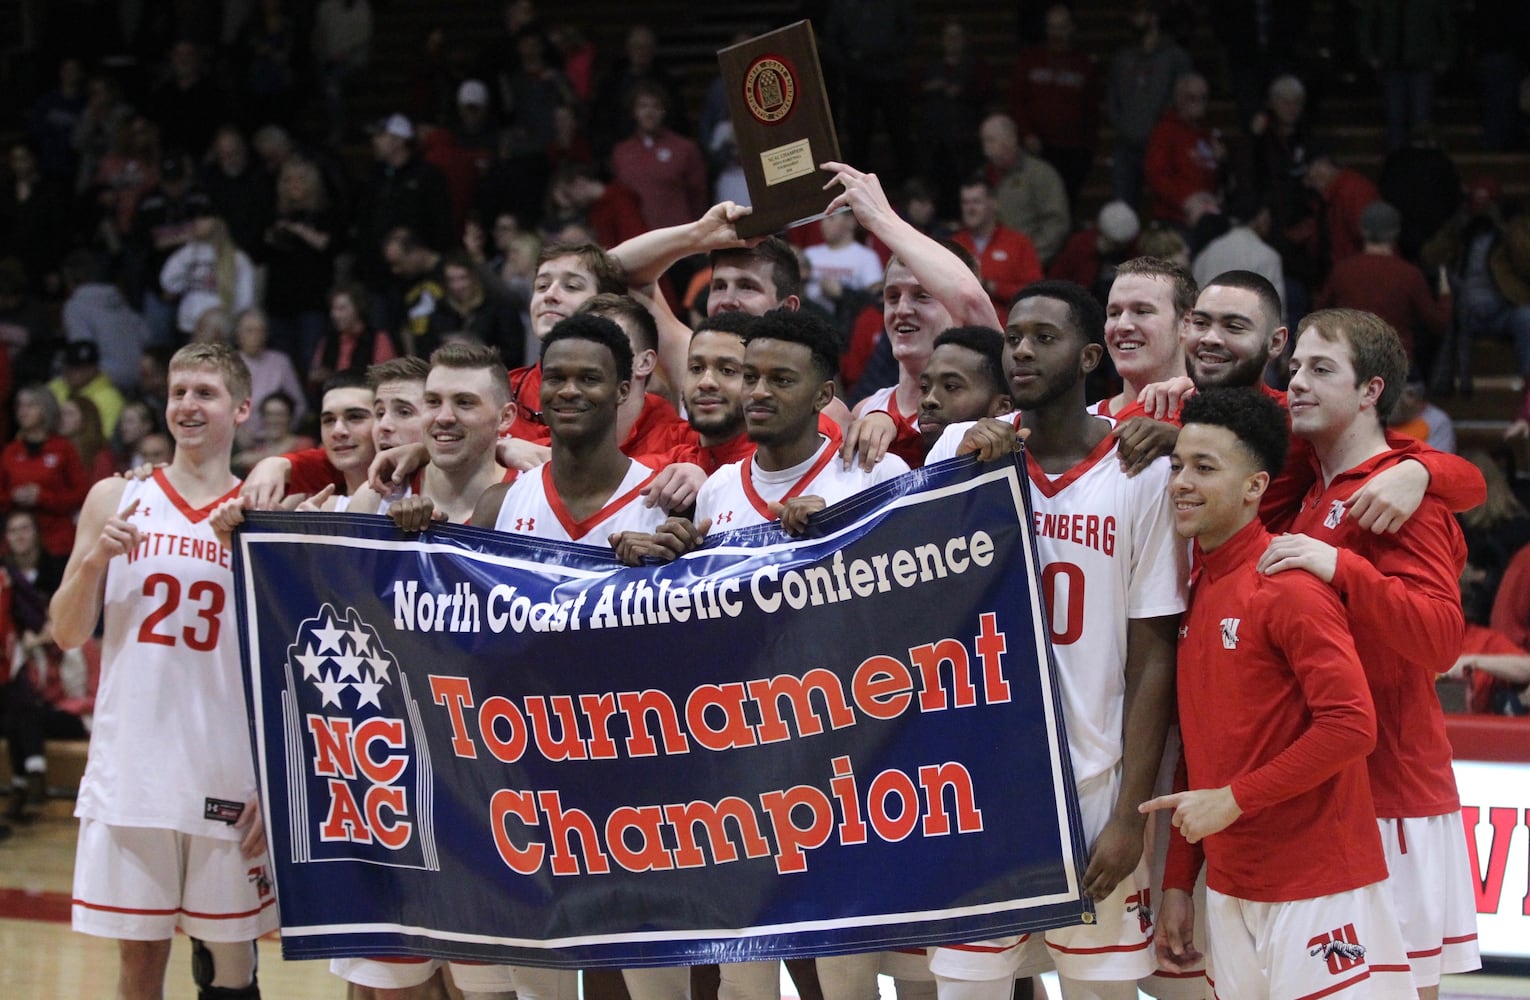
1164,520,1386,902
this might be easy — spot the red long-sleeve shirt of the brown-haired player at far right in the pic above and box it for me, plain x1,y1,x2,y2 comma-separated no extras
1291,451,1466,818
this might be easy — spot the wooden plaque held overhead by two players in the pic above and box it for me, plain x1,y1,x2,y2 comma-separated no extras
718,21,840,237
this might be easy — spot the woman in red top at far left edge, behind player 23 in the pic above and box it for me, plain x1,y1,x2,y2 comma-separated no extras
0,385,90,557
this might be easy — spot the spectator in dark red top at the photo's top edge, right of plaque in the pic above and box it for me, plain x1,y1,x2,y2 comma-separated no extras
1010,3,1100,203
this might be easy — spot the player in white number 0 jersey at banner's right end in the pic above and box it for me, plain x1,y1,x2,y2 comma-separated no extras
929,281,1187,1000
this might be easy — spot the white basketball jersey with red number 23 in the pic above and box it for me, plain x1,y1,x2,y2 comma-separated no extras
75,469,256,839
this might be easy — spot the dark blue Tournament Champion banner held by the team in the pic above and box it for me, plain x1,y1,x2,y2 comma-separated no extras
234,459,1092,968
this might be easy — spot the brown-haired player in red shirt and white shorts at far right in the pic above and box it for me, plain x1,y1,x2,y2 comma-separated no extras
1259,309,1481,1000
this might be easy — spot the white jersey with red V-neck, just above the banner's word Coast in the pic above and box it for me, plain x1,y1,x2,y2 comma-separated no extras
494,459,669,546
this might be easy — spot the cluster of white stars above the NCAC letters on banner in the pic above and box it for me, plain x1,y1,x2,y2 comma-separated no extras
288,604,398,711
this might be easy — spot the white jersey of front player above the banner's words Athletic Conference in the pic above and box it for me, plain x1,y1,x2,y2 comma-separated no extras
696,437,909,531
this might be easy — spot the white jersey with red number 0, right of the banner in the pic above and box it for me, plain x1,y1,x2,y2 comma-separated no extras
926,417,1189,787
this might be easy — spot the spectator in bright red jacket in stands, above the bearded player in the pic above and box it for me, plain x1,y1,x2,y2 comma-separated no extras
1143,73,1227,226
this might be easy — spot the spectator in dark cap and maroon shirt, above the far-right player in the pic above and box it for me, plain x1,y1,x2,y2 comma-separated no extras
1317,202,1450,372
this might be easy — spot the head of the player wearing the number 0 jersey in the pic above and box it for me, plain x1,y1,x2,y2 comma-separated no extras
1004,295,1100,410
